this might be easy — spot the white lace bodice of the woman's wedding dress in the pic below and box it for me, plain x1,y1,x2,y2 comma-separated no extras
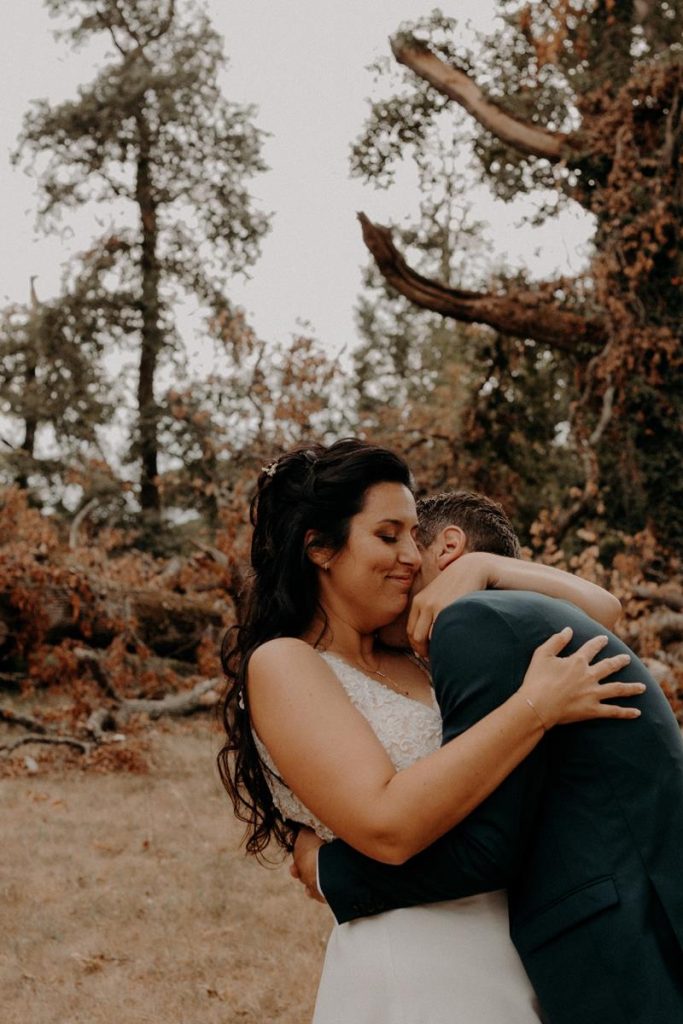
254,651,441,841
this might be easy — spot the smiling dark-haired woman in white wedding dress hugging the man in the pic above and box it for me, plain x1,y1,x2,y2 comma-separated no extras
218,439,642,1024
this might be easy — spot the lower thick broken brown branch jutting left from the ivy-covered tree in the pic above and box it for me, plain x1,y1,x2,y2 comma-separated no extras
358,213,607,354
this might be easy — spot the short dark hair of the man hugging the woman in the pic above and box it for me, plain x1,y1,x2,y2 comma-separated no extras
417,490,521,558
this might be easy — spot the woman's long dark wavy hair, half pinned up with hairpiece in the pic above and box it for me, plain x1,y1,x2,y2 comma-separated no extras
218,437,413,855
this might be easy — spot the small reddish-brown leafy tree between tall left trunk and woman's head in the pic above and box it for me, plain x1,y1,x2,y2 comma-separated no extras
161,310,350,531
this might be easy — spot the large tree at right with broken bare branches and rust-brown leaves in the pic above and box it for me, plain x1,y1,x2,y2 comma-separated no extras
354,0,683,546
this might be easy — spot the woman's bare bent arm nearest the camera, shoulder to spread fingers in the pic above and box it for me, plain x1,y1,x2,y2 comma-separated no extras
249,624,642,863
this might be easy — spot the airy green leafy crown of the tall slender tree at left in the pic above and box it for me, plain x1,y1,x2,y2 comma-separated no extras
17,0,267,284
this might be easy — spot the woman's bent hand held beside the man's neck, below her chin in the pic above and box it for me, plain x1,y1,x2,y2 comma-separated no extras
407,551,497,658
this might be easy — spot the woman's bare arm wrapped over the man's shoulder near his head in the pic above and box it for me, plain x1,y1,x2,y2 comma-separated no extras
408,551,622,656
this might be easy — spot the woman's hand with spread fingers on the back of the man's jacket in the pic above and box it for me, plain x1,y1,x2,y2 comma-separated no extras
519,626,646,729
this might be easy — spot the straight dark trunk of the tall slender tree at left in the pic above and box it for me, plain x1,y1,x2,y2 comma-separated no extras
135,113,163,526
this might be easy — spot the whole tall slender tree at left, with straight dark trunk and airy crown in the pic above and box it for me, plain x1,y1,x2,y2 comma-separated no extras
16,0,267,527
